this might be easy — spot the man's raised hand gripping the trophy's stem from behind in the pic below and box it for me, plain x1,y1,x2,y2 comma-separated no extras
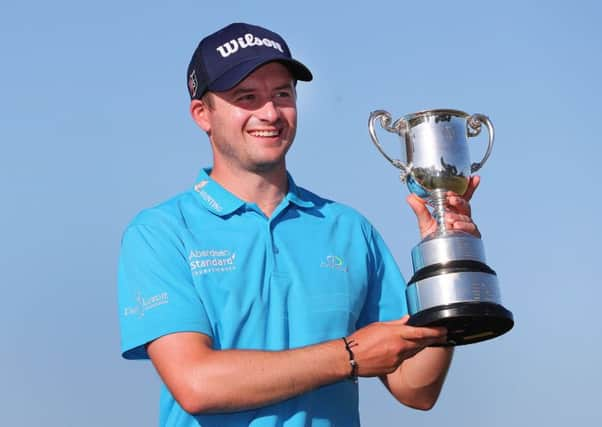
406,176,481,238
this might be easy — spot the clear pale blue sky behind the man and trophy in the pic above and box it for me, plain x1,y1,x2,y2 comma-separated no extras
0,0,602,427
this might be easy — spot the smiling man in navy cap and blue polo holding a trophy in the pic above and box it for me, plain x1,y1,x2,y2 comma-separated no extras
119,23,478,427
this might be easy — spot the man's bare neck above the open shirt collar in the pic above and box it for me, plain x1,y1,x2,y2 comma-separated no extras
211,165,288,218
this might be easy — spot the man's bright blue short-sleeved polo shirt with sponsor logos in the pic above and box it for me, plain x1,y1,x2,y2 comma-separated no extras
118,170,407,427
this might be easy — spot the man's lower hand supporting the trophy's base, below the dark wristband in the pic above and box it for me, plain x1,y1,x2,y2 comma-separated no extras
348,316,447,377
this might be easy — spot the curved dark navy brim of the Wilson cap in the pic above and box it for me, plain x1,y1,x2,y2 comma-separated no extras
207,56,313,92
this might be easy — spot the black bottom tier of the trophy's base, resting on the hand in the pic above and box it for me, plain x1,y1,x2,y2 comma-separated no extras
408,302,514,347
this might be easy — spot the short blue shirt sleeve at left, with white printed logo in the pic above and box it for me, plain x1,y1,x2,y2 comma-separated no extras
118,224,212,359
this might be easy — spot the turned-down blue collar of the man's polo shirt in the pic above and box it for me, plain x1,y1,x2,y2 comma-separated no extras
193,168,314,216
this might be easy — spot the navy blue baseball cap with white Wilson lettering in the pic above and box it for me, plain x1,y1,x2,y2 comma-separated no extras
186,23,313,99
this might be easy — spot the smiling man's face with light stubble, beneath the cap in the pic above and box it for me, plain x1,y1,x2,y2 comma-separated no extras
203,62,297,172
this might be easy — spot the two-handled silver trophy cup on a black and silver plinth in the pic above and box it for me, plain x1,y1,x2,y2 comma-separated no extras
368,109,514,346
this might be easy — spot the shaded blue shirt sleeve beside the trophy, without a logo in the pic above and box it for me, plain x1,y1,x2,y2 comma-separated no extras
357,226,408,328
